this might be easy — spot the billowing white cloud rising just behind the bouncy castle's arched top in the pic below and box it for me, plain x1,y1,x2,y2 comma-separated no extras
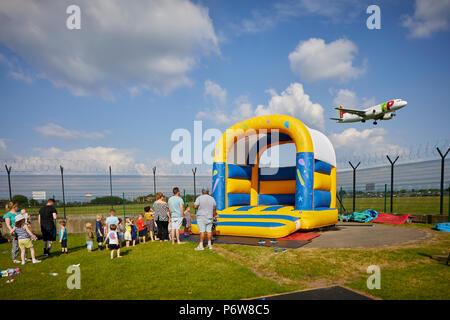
197,83,325,129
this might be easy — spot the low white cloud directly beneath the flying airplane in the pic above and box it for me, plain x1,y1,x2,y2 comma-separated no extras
329,128,408,158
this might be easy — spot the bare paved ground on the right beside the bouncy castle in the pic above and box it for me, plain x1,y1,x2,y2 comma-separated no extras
303,222,433,248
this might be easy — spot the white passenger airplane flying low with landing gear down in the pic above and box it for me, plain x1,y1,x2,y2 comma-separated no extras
330,99,408,125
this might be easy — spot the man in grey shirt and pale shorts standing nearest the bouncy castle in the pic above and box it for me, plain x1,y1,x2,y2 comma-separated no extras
194,188,219,250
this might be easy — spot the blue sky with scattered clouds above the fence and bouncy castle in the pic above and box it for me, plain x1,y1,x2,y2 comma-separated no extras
0,0,450,175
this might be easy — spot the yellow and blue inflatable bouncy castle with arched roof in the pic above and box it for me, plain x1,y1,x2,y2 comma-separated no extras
192,115,338,238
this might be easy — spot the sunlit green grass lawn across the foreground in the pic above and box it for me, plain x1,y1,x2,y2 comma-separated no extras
0,225,450,300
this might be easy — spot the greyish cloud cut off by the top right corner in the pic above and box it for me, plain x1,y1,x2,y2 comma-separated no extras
402,0,450,38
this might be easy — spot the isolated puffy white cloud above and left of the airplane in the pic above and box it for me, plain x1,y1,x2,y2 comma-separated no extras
289,38,366,82
